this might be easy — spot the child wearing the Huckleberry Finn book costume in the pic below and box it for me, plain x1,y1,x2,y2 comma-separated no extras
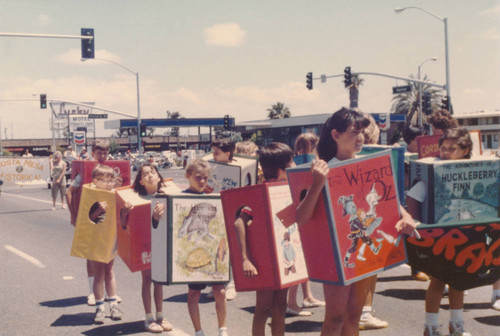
406,127,472,336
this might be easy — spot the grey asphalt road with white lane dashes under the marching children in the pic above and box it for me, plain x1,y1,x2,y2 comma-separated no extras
0,169,500,336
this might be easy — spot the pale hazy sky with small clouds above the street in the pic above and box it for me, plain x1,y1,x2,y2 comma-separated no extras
0,0,500,139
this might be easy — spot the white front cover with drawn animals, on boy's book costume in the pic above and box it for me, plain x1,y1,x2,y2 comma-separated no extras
171,197,229,282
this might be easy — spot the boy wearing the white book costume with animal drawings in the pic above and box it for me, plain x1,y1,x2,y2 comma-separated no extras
183,159,227,336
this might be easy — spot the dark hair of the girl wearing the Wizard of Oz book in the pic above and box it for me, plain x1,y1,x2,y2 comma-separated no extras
317,107,370,162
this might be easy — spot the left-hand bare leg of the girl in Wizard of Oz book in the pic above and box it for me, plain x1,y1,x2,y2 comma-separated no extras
321,284,352,336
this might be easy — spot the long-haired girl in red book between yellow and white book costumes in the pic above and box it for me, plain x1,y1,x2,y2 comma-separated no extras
120,163,172,333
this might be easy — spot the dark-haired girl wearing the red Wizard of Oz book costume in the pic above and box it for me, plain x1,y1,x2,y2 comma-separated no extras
297,108,416,336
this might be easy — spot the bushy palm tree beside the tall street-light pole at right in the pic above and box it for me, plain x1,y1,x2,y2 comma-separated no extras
391,75,441,125
